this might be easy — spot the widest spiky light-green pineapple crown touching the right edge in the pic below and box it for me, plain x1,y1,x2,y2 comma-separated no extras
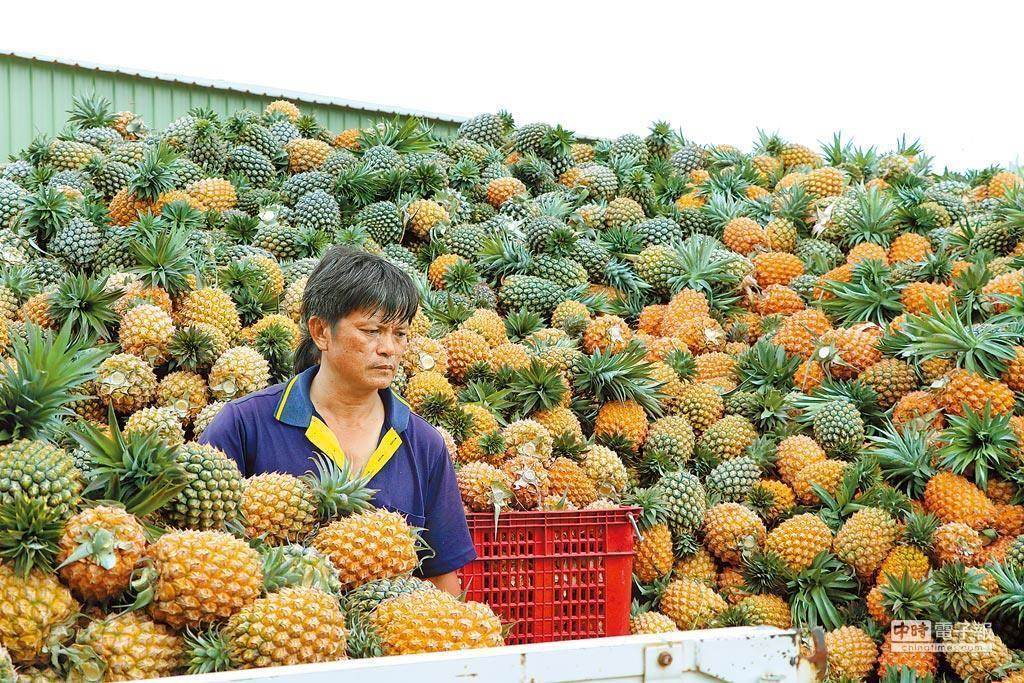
879,301,1021,377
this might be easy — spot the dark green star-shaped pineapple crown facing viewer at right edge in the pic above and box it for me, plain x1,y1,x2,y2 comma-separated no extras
938,403,1018,489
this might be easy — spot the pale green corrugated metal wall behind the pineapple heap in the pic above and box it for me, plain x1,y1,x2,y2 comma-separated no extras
0,54,459,162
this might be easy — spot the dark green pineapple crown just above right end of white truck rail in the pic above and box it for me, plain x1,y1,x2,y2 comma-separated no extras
786,552,860,630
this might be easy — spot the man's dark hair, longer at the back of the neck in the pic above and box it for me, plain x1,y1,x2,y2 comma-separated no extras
295,246,420,373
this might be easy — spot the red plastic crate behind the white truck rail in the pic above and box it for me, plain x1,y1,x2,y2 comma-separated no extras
461,508,637,645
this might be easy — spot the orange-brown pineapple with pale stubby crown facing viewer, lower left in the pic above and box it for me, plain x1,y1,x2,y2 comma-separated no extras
57,505,146,602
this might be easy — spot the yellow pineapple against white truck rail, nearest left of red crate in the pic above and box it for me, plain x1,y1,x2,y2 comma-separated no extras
370,589,504,654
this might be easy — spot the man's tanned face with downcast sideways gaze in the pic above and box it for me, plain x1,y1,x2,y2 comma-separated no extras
310,311,409,389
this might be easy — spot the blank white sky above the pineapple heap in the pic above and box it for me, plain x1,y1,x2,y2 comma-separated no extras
0,0,1024,170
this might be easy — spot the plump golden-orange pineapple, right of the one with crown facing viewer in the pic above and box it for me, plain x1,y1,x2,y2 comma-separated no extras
145,530,263,629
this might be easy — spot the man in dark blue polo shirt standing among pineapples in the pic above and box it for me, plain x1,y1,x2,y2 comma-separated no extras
200,247,476,594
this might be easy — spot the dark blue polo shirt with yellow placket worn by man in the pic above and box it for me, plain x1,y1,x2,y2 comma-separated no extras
199,366,476,577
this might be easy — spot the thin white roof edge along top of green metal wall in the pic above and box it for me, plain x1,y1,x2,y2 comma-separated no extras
0,50,466,123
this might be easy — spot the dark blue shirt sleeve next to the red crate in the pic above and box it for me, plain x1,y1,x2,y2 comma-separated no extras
420,432,476,578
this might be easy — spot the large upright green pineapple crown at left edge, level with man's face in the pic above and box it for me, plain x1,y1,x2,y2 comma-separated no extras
0,323,110,443
